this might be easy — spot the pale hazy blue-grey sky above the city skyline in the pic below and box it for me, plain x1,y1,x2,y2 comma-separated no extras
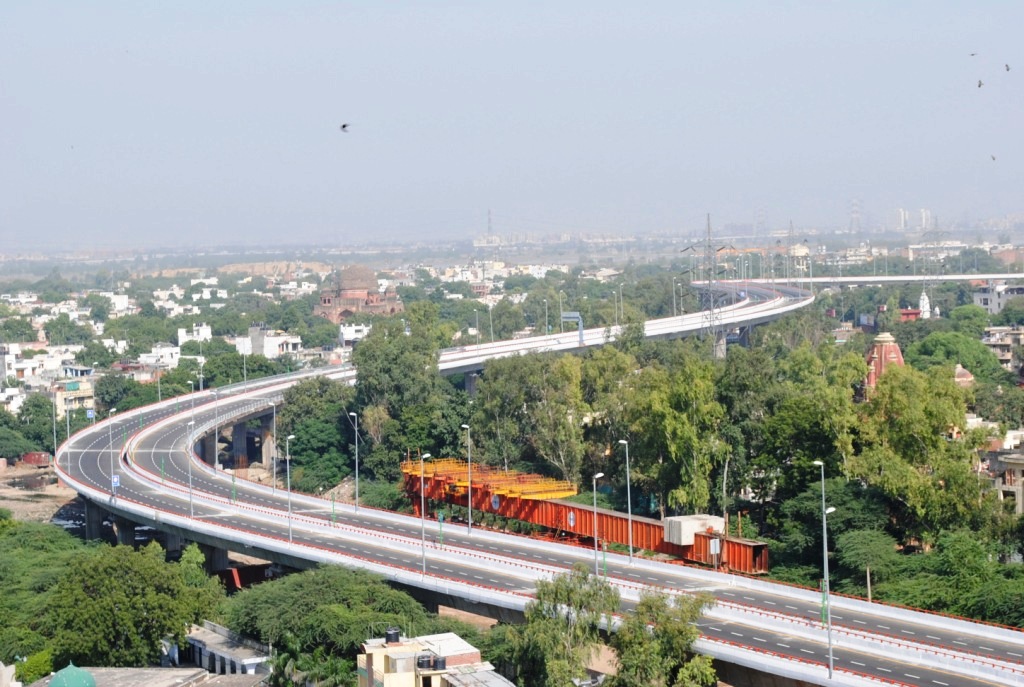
0,0,1024,252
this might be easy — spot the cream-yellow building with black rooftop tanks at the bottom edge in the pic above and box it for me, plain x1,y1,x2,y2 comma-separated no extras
356,628,514,687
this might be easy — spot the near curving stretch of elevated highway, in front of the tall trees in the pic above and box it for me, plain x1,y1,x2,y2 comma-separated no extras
56,288,1024,687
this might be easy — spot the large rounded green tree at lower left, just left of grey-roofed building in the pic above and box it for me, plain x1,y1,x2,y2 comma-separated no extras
49,543,189,667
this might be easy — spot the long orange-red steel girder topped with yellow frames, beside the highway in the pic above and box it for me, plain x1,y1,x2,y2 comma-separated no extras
401,459,768,574
